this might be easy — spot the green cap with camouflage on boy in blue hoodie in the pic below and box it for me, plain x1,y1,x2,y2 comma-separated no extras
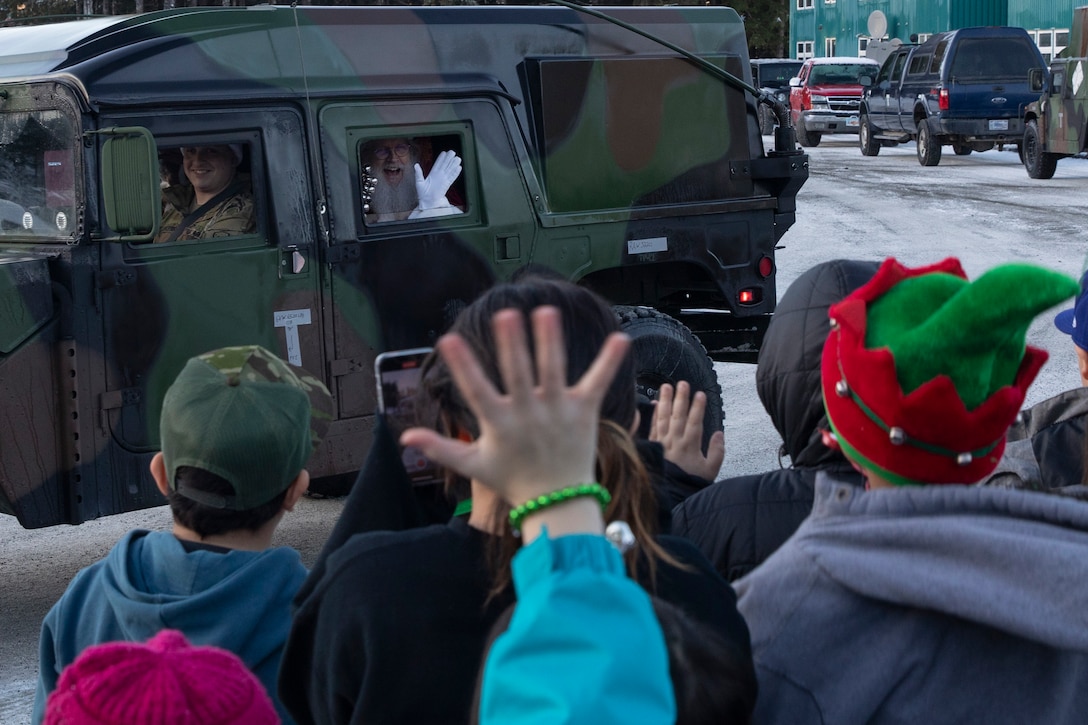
160,345,333,511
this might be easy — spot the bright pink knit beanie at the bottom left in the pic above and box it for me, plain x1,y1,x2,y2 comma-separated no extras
44,629,280,725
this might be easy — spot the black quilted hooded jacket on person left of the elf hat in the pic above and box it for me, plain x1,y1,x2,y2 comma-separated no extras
672,259,879,581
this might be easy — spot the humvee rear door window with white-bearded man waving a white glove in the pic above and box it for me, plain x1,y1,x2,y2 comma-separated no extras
359,134,468,224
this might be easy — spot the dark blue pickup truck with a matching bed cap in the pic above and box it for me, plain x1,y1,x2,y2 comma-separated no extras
857,27,1046,167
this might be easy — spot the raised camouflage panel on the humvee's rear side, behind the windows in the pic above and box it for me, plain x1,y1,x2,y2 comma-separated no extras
526,57,752,213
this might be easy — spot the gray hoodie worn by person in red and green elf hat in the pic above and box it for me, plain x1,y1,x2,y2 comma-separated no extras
735,477,1088,724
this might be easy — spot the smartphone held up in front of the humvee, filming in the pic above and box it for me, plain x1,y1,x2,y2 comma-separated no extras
374,347,443,486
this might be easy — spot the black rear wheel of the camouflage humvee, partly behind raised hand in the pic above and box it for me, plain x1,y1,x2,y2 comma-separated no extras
613,305,725,452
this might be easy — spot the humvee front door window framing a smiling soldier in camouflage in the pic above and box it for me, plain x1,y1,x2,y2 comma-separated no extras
154,140,257,242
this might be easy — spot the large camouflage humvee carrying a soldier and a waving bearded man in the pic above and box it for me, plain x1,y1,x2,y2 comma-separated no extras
0,5,808,527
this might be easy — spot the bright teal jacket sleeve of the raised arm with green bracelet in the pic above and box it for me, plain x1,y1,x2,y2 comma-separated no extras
480,532,676,725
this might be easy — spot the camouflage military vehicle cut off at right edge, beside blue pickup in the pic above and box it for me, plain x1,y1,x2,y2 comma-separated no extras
1021,7,1088,179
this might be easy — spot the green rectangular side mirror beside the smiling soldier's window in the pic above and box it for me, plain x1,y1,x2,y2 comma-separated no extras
98,126,162,242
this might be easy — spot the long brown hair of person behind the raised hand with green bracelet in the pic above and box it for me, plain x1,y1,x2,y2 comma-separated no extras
423,277,679,598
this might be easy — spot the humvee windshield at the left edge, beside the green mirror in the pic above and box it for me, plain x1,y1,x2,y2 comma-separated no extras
0,110,78,242
